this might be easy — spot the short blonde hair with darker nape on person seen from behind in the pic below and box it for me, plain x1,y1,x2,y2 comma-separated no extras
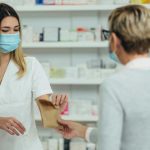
109,5,150,54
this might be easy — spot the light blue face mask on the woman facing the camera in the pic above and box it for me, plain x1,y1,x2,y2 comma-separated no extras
0,33,21,53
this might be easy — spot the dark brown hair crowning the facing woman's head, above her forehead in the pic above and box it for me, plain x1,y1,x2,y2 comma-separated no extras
0,3,20,29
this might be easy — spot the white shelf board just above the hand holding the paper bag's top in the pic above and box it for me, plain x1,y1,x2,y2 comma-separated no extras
50,79,104,85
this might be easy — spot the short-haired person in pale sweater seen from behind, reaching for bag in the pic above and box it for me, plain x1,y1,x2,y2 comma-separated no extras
59,5,150,150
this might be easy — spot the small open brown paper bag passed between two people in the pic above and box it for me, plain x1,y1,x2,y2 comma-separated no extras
37,99,60,128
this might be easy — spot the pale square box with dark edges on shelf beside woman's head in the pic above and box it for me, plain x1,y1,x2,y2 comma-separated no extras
44,27,58,42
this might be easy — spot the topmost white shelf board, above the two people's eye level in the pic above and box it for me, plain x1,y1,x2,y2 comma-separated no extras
16,4,150,12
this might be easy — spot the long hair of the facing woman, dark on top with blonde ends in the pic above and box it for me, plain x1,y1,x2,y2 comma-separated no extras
0,3,26,78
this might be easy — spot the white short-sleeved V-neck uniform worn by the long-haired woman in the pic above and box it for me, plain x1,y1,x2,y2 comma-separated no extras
0,57,52,150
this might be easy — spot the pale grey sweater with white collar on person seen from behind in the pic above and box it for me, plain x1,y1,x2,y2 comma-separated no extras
89,58,150,150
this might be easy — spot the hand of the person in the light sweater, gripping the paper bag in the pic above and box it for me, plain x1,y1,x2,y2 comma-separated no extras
58,120,87,139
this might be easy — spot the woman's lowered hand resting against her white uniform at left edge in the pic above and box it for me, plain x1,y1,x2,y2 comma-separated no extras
0,117,25,136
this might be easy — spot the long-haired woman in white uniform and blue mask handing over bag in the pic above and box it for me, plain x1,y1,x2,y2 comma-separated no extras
0,3,67,150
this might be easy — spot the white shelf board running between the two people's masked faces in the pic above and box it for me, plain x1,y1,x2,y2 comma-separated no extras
22,41,108,48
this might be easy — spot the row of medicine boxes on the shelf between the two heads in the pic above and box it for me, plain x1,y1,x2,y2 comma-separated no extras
22,25,101,42
